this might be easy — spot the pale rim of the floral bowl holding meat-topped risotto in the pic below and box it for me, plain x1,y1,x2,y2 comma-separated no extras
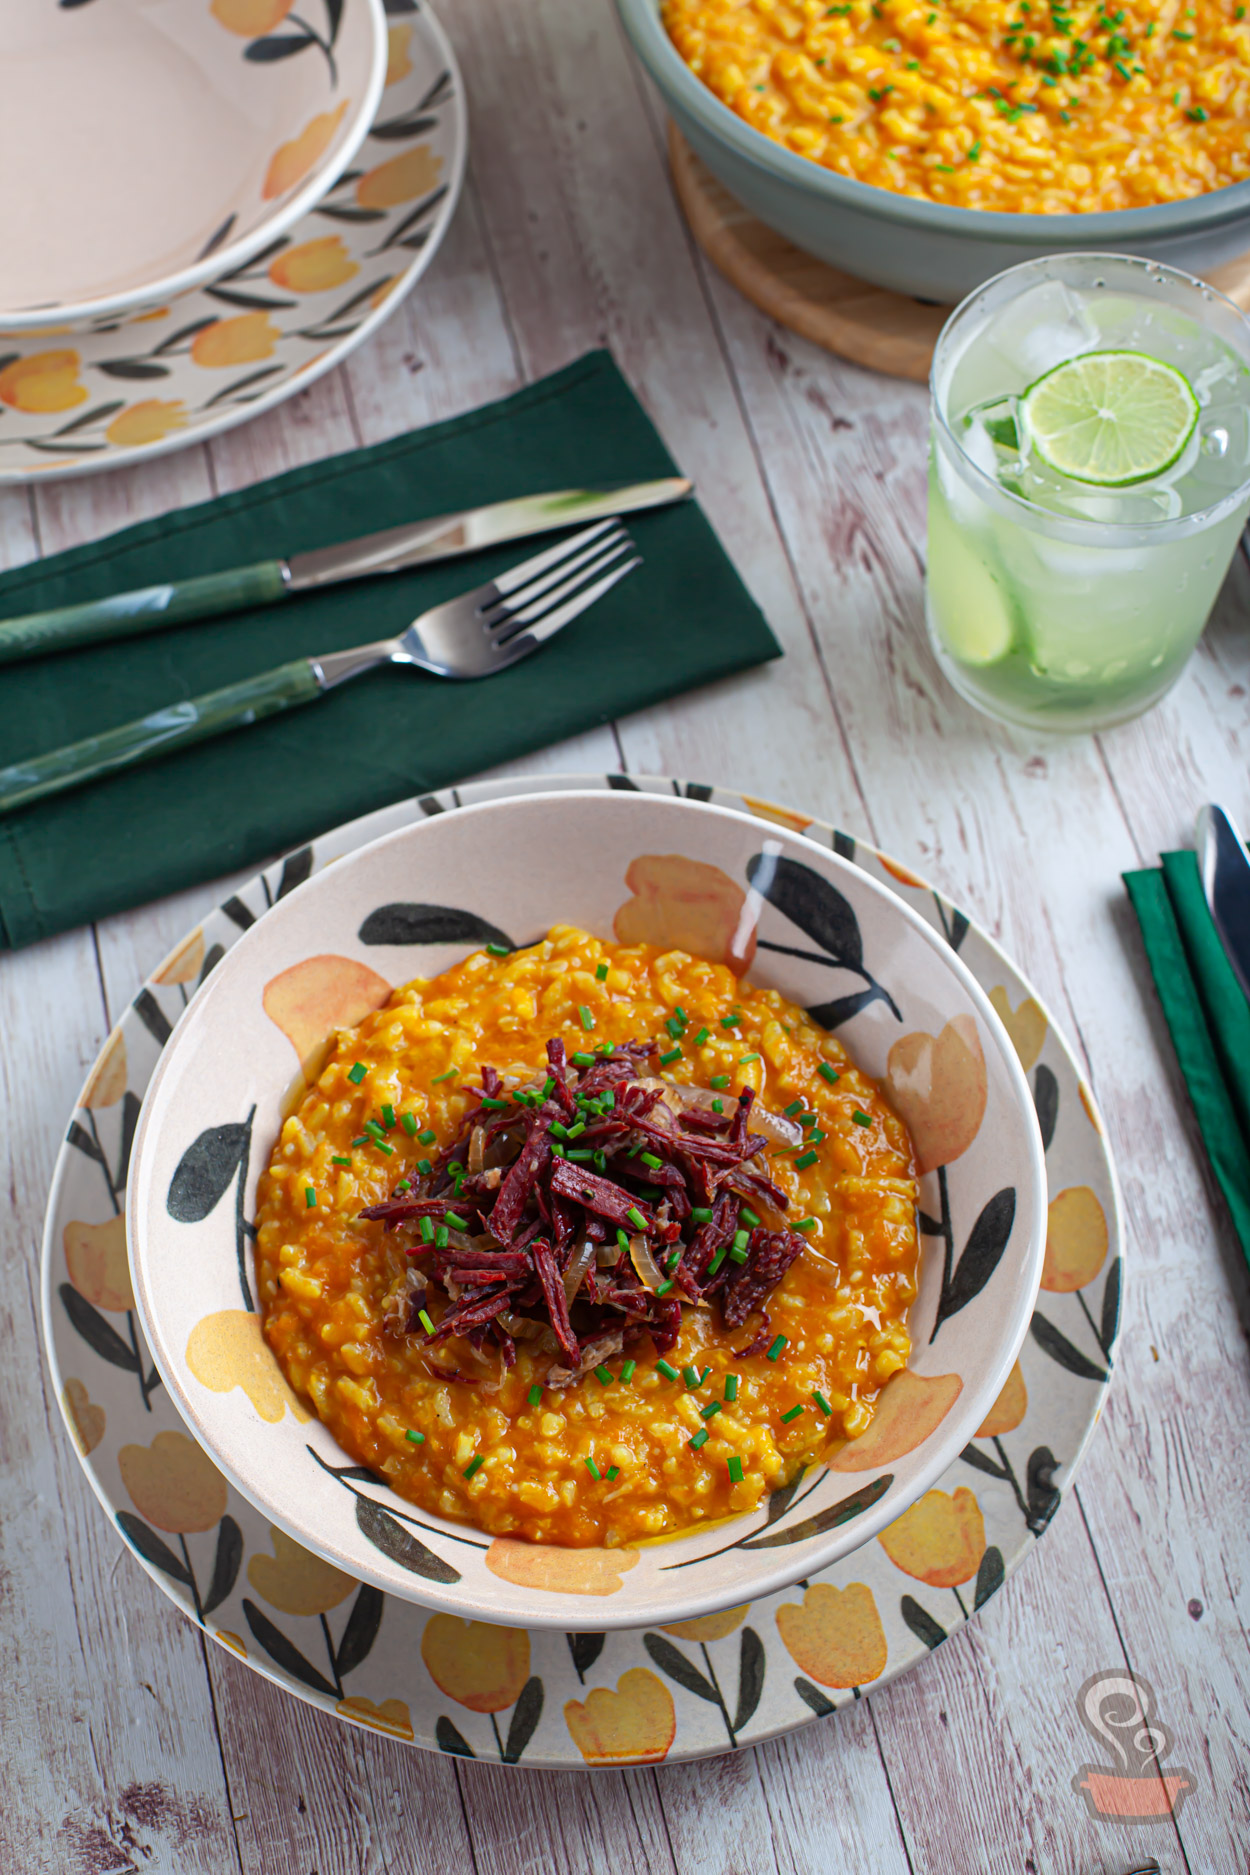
124,789,1048,1633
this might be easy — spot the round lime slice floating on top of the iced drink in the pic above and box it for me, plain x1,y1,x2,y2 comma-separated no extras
1019,351,1198,488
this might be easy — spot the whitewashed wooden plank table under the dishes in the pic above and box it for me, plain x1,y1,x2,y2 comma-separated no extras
0,0,1250,1875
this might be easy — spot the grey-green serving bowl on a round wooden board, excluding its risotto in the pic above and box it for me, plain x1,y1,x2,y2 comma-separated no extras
617,0,1250,304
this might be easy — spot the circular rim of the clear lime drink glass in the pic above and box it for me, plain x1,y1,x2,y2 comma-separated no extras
930,249,1250,546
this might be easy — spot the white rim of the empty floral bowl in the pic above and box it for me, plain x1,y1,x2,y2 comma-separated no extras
0,0,388,336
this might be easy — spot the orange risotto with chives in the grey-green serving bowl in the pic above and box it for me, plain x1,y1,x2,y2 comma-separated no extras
663,0,1250,216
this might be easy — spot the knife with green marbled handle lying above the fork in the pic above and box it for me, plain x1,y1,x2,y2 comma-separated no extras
0,476,693,664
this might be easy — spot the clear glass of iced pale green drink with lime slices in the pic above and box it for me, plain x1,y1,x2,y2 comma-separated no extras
926,255,1250,731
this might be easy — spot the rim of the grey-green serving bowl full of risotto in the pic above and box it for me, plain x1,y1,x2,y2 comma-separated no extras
617,0,1250,253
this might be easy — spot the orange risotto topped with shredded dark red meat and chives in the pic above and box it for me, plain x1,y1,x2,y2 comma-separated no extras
257,926,916,1547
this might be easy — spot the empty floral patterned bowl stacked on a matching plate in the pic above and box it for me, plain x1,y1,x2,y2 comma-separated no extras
0,0,386,332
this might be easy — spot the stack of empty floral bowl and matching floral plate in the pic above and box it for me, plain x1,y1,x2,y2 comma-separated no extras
0,0,467,482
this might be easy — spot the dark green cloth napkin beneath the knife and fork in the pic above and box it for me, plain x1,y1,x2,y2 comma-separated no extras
0,353,781,949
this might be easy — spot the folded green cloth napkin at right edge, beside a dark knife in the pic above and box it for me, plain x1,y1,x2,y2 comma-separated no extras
1124,853,1250,1260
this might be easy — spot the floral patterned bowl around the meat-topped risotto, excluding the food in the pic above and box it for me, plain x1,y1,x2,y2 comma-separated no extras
126,791,1046,1629
